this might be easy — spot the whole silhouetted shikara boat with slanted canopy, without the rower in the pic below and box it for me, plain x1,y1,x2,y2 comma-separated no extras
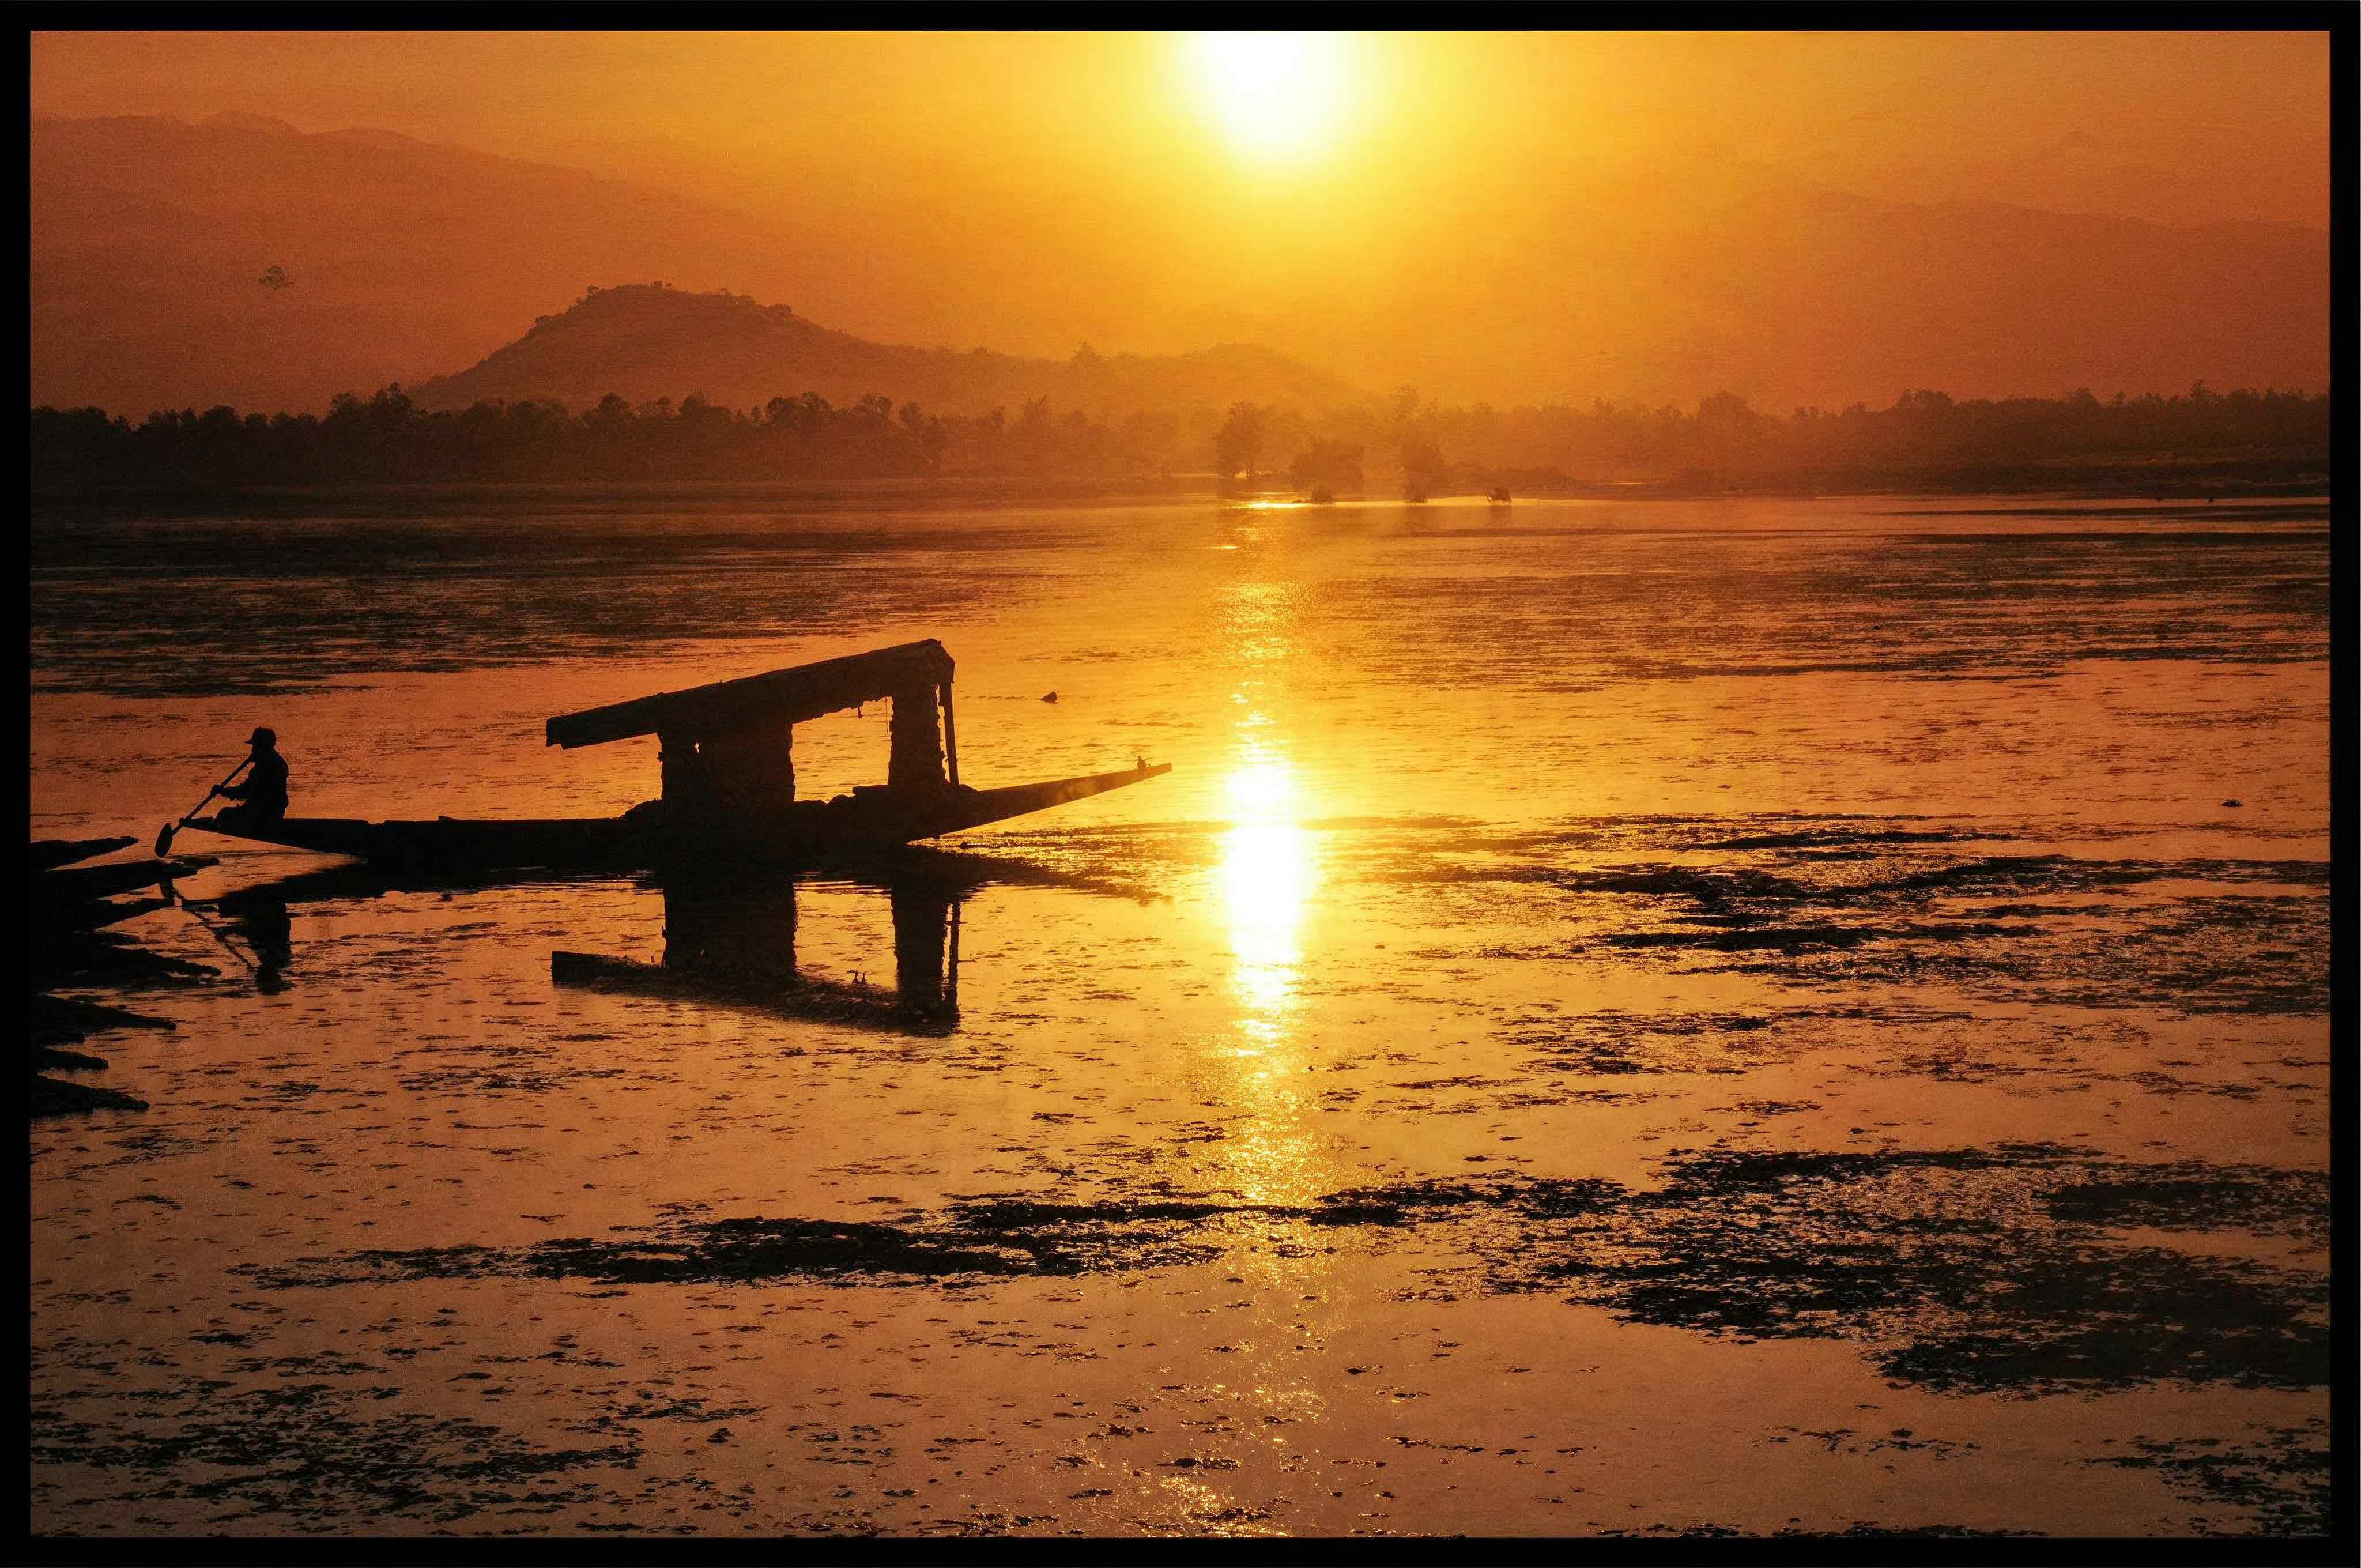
189,638,1171,872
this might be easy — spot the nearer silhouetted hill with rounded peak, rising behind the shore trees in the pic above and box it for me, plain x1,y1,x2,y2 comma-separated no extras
411,284,1355,416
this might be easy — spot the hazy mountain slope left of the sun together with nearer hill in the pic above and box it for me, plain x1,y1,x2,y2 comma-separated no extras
31,114,1351,418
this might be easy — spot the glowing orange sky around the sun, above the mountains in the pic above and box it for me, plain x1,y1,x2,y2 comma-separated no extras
31,33,2328,410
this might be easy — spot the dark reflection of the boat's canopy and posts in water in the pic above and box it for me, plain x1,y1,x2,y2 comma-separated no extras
550,874,973,1034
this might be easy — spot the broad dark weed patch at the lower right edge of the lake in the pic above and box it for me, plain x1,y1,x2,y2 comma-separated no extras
1502,1145,2328,1396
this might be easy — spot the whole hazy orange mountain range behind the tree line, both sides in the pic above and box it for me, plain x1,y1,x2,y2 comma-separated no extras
28,114,2328,418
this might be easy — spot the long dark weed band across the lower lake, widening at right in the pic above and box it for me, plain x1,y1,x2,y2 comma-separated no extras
250,1143,2328,1396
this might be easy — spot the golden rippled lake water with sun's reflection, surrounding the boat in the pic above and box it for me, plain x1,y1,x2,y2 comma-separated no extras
31,491,2330,1535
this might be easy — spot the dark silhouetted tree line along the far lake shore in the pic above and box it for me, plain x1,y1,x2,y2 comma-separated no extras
28,383,2328,496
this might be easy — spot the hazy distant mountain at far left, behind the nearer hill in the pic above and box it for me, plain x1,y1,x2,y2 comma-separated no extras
28,114,895,411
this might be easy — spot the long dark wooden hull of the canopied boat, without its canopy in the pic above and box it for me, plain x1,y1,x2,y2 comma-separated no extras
189,763,1171,872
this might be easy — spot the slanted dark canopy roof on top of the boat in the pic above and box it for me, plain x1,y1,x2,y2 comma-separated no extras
548,638,952,751
